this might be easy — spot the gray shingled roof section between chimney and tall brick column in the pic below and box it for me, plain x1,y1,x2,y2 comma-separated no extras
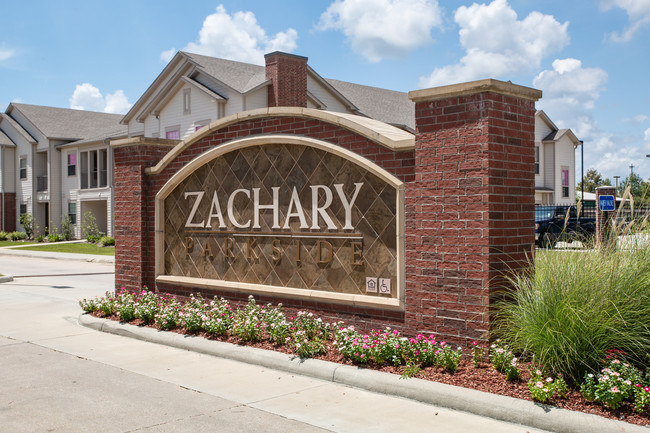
326,79,415,130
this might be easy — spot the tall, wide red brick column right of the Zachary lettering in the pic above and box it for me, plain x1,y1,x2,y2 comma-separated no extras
406,80,541,343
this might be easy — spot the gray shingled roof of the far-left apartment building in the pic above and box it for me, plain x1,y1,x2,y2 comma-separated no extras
11,103,123,140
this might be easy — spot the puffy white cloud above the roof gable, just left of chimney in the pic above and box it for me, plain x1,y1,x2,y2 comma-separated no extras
166,5,298,64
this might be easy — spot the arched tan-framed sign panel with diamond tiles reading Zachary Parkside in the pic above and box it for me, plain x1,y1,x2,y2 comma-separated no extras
156,135,404,309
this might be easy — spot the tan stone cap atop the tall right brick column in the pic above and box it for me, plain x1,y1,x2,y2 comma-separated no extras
409,78,542,102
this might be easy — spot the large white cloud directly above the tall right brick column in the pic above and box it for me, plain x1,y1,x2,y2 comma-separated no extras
420,0,569,87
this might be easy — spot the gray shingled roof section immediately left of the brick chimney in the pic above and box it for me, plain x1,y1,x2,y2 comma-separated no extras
183,51,266,93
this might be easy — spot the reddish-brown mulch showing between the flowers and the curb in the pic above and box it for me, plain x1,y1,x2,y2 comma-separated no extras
92,311,650,426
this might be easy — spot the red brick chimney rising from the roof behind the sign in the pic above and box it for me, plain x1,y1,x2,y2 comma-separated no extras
264,51,307,107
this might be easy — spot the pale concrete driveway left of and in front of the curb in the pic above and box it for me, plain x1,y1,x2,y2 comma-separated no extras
0,255,538,433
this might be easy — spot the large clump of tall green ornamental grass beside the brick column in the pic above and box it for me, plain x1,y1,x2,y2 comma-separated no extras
495,245,650,384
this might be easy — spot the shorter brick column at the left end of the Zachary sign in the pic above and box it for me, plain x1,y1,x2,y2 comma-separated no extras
111,137,174,290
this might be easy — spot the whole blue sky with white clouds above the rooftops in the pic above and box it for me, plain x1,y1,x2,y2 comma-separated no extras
0,0,650,179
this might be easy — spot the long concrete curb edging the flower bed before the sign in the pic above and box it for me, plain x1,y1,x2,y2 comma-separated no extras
79,314,650,433
